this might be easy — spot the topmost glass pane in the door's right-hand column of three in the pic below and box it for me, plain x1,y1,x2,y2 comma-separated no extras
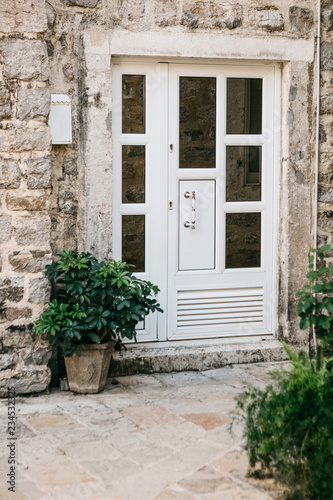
227,78,262,134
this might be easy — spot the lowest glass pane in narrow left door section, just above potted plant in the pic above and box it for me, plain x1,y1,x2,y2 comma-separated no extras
122,215,145,273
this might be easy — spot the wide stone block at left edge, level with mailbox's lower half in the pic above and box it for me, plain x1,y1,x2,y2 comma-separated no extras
0,122,51,152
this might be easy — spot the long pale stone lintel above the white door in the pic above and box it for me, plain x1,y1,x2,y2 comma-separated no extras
85,29,315,62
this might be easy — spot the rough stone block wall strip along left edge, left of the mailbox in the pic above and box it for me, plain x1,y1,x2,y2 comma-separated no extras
0,0,52,394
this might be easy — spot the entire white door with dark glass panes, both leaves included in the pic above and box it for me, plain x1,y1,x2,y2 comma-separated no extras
114,63,278,340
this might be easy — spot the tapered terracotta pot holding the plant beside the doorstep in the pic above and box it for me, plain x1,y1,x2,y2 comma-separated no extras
65,341,115,394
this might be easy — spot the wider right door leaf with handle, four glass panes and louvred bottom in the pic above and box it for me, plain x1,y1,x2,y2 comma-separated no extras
168,65,274,340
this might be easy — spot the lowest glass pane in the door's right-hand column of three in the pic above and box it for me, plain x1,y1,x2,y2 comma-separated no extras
226,213,261,269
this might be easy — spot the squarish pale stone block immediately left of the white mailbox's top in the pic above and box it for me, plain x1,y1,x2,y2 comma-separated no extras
16,88,51,120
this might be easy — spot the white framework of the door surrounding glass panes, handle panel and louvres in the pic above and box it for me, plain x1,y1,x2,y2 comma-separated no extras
113,61,280,342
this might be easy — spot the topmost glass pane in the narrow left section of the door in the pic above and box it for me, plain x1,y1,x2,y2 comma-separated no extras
122,75,146,134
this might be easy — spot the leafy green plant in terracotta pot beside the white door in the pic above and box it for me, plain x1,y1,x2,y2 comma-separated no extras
35,249,162,393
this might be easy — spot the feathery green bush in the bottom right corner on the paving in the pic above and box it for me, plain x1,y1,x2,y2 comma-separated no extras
232,346,333,500
